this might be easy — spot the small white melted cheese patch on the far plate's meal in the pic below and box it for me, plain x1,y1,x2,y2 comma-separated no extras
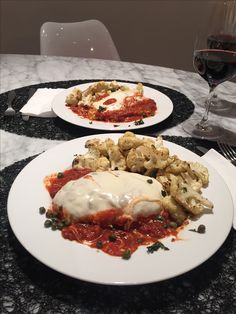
93,89,134,111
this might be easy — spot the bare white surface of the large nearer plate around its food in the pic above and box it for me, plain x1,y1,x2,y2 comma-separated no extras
8,133,233,284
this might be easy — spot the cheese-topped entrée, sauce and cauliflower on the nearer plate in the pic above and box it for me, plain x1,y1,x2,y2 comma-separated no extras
42,132,213,259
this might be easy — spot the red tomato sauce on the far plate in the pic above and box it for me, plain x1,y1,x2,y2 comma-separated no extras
68,96,157,123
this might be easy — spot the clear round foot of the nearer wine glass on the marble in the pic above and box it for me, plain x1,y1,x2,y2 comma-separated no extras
182,119,223,140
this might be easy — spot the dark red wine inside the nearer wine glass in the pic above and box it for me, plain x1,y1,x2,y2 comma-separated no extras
193,49,236,87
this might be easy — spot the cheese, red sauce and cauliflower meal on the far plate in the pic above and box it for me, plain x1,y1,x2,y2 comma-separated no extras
66,81,157,124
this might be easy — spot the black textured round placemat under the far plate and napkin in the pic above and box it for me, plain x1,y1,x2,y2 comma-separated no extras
0,79,194,140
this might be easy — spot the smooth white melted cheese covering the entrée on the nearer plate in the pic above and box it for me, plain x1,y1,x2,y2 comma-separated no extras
53,171,162,219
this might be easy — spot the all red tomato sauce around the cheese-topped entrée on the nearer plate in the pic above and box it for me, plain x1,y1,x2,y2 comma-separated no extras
43,169,181,256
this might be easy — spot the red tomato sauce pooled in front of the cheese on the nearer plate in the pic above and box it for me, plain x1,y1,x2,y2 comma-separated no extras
62,212,177,256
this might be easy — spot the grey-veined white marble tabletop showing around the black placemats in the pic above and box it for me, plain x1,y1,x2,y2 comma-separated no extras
0,55,236,169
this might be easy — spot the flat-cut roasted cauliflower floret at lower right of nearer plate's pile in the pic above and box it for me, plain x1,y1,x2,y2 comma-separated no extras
170,175,213,215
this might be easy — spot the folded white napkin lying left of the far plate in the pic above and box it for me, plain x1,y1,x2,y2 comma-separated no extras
20,88,64,118
